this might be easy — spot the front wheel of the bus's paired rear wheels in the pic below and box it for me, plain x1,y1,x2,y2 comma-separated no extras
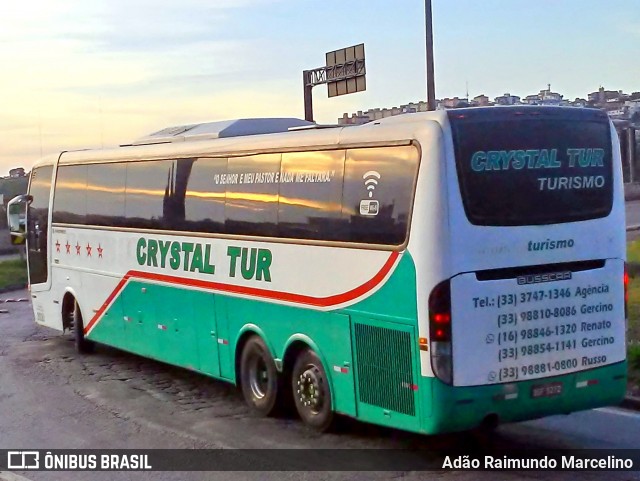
240,336,280,416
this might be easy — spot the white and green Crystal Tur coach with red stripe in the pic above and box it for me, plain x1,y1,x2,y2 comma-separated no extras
10,106,627,433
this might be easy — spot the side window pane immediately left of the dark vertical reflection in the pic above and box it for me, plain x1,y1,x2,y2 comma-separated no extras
125,160,176,229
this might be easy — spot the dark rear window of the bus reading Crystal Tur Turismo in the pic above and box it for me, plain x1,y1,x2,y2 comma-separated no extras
448,107,613,226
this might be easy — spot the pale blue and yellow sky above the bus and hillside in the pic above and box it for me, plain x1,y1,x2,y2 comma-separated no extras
0,0,640,176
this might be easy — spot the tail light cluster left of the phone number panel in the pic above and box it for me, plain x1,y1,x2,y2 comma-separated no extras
429,280,453,384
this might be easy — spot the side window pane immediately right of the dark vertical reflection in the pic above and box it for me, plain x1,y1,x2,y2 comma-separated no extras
181,159,227,233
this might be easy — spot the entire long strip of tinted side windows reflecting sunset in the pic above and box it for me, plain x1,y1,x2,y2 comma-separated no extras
43,147,418,245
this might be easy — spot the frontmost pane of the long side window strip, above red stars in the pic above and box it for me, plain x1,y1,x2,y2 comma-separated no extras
53,165,87,224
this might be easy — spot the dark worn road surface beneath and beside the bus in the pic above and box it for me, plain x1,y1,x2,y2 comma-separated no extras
0,291,640,481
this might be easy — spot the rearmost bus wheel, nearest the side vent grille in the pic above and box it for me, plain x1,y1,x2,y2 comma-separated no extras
291,349,334,432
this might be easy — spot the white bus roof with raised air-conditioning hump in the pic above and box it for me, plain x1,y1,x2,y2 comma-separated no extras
36,105,606,169
